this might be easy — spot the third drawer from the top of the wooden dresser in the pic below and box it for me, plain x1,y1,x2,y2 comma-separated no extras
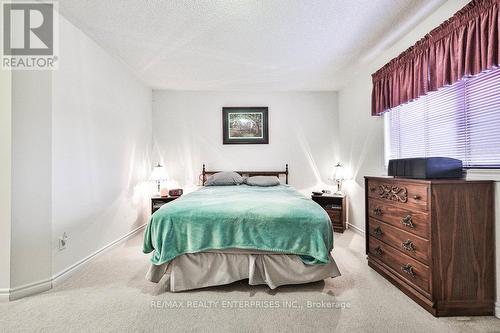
369,219,430,265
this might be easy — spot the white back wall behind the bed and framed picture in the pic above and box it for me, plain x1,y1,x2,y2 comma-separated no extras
153,91,337,191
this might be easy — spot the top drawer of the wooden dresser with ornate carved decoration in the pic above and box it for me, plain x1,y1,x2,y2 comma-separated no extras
368,179,429,211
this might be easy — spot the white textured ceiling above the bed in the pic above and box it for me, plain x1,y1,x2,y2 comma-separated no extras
59,0,444,91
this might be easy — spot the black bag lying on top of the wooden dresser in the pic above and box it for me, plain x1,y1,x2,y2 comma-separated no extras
388,157,462,179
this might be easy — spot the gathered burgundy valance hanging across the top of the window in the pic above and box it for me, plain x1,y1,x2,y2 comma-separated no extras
372,0,500,115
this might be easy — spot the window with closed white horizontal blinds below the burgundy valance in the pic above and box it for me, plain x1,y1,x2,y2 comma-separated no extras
384,69,500,168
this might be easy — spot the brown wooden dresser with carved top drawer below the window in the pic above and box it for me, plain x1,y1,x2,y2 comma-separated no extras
365,177,495,316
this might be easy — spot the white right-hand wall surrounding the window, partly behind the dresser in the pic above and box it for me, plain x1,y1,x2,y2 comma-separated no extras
339,0,500,317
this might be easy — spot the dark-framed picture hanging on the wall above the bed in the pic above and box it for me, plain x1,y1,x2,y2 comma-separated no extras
222,106,269,145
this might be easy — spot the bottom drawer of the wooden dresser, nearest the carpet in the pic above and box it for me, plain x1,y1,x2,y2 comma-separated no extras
369,236,430,293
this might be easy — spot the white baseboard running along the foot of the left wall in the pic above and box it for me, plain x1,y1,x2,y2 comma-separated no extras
0,224,146,302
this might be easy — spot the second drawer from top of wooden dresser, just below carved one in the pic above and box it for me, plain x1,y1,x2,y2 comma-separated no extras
368,199,430,239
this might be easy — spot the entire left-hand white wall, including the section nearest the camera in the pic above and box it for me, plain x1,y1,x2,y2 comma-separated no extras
0,11,152,300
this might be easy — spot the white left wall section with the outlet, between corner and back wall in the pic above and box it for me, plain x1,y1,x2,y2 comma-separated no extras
52,17,152,276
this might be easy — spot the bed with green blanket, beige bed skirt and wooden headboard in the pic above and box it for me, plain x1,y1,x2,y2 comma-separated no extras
143,165,340,292
